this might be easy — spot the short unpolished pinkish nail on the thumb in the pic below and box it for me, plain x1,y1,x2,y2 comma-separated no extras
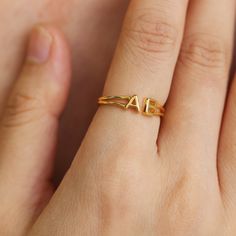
27,26,52,64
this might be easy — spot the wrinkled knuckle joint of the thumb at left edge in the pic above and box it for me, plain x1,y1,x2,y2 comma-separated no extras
3,92,41,127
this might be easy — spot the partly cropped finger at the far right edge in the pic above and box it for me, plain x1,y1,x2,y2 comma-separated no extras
218,75,236,206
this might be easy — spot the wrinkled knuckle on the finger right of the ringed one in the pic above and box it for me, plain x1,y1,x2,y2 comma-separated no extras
180,34,226,69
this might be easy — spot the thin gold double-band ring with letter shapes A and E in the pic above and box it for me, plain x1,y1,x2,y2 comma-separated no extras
98,95,165,117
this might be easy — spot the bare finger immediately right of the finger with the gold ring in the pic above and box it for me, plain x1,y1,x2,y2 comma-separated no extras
160,0,235,170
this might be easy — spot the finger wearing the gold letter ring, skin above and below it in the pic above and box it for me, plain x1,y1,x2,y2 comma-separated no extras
86,0,187,155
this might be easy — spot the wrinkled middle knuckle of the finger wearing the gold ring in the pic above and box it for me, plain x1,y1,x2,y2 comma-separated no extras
123,10,177,57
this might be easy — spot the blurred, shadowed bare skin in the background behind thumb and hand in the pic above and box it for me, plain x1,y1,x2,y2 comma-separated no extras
0,0,128,182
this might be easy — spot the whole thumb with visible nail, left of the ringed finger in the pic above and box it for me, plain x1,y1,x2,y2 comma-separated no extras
0,26,70,235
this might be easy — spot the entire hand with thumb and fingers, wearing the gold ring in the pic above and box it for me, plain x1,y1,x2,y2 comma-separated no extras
0,0,236,236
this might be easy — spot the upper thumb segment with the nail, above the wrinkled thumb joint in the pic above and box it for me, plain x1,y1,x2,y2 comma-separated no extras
19,24,71,116
